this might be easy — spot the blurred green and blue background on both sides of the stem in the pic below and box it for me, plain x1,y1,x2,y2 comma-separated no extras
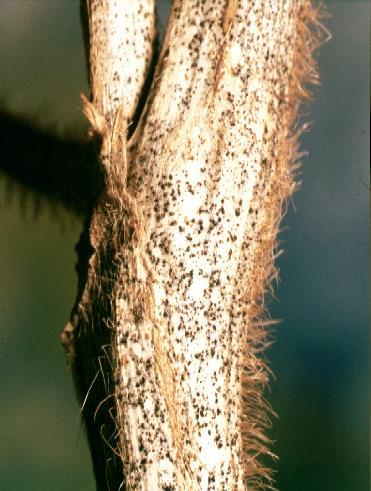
0,0,369,491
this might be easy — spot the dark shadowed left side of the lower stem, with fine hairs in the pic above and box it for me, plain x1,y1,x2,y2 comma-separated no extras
67,236,125,491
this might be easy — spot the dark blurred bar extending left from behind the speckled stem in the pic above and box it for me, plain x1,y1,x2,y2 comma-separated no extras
0,112,103,217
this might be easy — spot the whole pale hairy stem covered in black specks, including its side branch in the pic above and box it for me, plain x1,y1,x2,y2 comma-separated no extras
65,0,321,491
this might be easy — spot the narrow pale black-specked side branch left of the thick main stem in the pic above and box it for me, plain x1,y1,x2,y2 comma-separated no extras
87,0,155,127
